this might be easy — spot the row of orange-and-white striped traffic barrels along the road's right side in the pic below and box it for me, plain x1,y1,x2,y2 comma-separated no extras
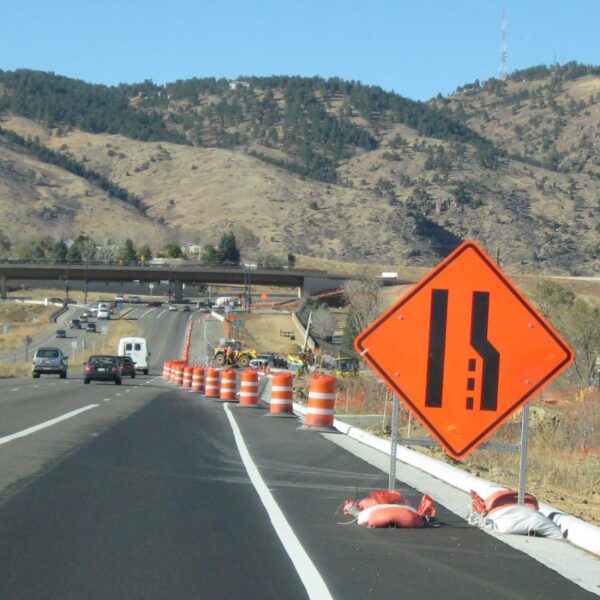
163,360,336,431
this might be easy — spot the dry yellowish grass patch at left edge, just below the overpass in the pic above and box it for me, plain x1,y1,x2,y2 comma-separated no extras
0,302,58,352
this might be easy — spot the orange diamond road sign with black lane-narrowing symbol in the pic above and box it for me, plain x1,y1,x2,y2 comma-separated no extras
355,242,573,459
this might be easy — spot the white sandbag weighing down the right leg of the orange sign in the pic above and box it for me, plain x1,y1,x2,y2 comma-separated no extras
469,505,563,540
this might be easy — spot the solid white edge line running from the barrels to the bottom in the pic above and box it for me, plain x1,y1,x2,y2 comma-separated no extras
223,404,332,600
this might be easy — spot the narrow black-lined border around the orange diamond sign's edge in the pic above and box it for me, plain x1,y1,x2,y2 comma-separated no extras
354,241,574,459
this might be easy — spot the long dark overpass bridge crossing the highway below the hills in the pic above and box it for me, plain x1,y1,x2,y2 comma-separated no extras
0,262,351,298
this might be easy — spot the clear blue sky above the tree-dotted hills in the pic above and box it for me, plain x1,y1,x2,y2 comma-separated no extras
0,0,600,100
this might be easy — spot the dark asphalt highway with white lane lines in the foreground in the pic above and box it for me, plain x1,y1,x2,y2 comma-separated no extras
0,308,597,600
